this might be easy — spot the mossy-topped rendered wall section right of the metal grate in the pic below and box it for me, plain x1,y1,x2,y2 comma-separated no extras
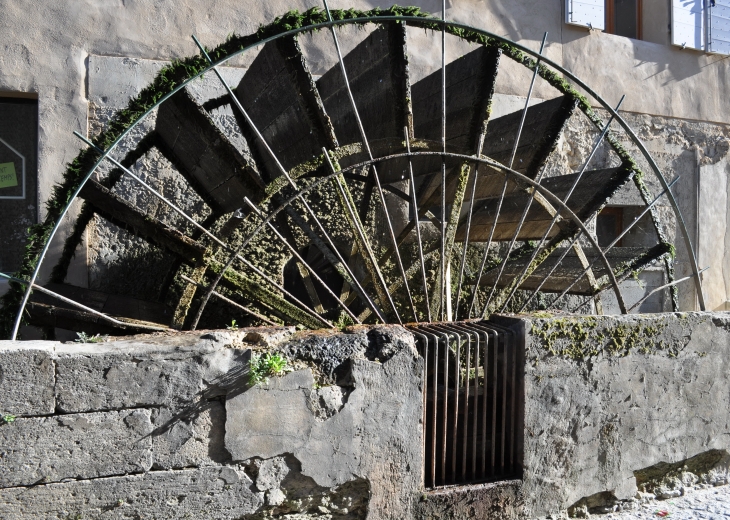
498,313,730,518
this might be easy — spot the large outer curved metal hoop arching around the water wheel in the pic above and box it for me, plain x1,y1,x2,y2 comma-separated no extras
10,11,705,340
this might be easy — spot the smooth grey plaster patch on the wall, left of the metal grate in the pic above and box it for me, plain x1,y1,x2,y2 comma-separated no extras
225,346,423,518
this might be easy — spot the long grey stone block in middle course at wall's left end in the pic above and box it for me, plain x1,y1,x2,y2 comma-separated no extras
0,410,152,490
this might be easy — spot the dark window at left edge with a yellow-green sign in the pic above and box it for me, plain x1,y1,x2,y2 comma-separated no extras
0,93,38,273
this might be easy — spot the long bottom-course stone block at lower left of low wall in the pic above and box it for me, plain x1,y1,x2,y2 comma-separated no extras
0,466,263,520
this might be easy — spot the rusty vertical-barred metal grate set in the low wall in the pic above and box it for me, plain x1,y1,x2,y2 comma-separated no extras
411,322,524,488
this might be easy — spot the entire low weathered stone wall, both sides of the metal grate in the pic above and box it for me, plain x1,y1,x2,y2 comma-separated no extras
0,313,730,520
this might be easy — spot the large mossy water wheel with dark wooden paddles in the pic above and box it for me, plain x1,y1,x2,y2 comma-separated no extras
3,7,701,337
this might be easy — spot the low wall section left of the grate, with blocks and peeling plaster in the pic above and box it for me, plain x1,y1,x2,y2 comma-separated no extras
0,322,422,519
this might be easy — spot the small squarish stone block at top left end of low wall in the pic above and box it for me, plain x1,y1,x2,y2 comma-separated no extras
0,341,57,415
